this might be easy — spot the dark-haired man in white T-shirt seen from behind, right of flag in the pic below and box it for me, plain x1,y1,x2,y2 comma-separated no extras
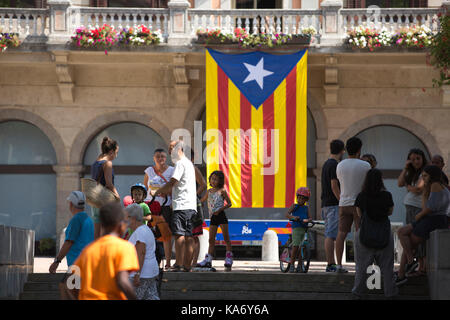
336,137,370,273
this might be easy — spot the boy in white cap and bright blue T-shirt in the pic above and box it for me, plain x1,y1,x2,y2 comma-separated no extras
49,191,94,273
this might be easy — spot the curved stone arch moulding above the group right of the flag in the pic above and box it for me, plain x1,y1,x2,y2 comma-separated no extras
339,114,442,155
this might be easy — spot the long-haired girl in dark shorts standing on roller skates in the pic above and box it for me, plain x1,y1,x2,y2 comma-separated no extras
197,171,233,269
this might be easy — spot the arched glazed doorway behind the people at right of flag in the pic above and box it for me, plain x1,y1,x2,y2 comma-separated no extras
357,125,430,222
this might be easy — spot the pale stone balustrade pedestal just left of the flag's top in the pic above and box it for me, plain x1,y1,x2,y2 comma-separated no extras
167,0,191,46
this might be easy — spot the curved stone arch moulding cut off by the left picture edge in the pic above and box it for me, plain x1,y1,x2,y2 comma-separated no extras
0,109,68,166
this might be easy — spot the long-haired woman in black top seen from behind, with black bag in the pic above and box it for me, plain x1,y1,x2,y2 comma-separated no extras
352,169,398,297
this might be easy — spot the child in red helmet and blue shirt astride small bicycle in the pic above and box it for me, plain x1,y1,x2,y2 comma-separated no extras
286,187,312,272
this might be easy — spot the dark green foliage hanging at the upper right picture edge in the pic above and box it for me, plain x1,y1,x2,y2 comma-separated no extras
429,12,450,87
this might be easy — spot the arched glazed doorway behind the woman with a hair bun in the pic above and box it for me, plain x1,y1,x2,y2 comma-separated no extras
83,122,168,198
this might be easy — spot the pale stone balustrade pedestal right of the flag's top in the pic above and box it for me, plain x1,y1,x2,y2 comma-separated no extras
320,0,342,46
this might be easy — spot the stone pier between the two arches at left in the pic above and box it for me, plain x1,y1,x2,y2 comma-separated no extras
53,165,83,246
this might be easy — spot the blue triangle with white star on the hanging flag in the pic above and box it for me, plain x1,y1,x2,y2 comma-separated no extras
208,49,306,109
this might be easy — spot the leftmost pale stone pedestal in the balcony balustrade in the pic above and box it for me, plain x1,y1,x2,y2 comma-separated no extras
48,0,72,43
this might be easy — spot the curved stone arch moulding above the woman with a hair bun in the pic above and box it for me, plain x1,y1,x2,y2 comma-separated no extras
70,111,170,165
